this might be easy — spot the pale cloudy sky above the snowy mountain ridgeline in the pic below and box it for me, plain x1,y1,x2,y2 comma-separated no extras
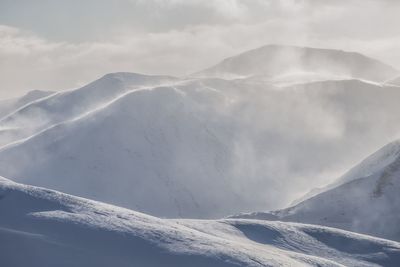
0,0,400,98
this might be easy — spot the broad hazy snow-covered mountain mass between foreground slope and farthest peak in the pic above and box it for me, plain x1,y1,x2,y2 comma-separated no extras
0,46,400,218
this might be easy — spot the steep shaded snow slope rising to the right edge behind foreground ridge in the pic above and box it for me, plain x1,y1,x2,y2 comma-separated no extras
231,141,400,240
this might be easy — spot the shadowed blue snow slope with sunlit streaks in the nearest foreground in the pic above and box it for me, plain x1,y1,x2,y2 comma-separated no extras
0,178,400,267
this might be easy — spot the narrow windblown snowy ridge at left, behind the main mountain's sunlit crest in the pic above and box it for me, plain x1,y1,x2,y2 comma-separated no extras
0,72,177,147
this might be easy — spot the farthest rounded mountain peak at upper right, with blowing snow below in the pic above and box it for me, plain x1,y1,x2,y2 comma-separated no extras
194,45,399,83
